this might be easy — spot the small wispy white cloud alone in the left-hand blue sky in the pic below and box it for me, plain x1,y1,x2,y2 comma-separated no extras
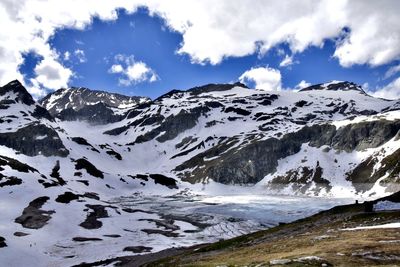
108,54,159,86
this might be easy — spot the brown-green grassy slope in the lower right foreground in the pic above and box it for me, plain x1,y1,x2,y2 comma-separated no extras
143,193,400,267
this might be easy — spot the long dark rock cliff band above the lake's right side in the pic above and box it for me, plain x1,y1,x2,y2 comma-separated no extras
175,120,400,184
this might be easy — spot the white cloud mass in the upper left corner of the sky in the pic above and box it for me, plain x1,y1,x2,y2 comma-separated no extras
0,0,136,96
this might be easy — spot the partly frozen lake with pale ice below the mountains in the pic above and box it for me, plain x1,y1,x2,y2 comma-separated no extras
114,194,353,244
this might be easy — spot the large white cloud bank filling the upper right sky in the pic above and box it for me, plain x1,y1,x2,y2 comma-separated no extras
145,0,400,67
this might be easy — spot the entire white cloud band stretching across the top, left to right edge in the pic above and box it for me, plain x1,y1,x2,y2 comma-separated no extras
0,0,400,96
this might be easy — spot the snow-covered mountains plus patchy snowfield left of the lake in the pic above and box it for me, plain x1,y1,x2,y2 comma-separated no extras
0,81,400,265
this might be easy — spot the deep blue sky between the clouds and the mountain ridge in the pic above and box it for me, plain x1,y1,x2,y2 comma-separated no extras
0,1,400,98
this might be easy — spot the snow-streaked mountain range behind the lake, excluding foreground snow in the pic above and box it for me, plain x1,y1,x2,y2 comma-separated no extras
0,78,400,195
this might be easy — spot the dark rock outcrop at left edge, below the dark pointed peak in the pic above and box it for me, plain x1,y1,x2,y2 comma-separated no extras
0,123,69,157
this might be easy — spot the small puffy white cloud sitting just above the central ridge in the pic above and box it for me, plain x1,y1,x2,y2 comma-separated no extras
239,67,282,91
